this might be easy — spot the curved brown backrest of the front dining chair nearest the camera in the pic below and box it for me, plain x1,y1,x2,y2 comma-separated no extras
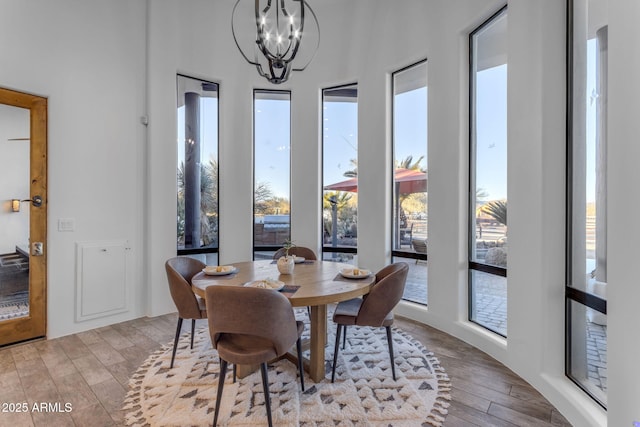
205,285,298,355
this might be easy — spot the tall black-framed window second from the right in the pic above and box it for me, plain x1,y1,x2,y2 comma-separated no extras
469,7,507,337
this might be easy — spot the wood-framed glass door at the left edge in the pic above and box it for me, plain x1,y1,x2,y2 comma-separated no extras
0,88,47,345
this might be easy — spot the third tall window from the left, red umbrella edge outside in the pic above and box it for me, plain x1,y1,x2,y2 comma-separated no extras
322,84,358,262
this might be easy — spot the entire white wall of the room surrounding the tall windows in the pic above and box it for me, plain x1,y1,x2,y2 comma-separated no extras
0,0,640,426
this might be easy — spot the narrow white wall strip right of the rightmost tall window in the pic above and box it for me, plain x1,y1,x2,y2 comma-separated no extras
607,0,640,427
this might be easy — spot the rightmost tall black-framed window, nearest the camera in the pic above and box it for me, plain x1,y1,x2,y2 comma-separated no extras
566,0,608,407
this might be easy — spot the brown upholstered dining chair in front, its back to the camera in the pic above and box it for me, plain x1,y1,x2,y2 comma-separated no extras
205,285,304,427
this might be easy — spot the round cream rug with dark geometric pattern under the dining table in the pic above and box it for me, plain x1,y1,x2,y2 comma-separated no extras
123,320,451,427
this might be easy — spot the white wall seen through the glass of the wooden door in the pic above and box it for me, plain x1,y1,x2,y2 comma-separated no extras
0,105,29,254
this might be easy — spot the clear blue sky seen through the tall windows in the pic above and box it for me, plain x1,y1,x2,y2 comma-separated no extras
178,60,564,207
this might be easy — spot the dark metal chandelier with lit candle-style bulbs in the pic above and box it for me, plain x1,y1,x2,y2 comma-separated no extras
231,0,320,84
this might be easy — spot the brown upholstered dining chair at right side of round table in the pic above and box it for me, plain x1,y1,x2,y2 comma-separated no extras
331,262,409,382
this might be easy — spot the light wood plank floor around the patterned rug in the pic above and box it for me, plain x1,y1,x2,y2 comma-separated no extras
0,314,570,427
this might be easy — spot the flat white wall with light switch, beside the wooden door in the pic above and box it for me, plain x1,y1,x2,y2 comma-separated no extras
0,0,146,337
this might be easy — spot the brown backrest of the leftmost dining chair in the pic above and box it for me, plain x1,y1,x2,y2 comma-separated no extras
164,257,206,319
